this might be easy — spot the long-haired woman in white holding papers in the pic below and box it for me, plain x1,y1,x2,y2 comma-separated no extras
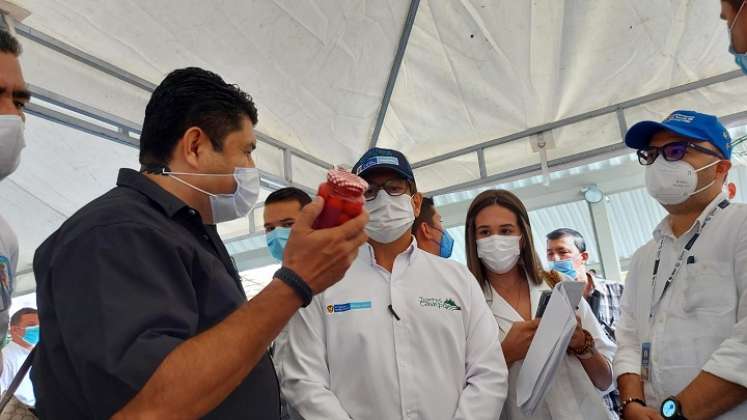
465,190,616,420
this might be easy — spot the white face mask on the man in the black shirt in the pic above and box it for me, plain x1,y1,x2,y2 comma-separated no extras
163,168,259,223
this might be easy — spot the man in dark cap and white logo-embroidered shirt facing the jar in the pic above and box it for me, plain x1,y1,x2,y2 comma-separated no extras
281,148,507,420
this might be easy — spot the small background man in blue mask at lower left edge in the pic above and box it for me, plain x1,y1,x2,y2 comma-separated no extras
0,308,39,420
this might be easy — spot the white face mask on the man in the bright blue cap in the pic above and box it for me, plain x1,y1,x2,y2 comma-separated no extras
645,158,721,206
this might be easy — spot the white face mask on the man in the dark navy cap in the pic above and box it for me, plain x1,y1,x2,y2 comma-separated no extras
366,190,415,244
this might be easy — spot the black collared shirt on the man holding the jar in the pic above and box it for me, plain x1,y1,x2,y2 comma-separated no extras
31,169,280,420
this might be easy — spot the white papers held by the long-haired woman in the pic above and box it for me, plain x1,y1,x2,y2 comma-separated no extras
516,281,584,416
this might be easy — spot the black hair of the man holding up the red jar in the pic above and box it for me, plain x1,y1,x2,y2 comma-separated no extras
140,67,257,166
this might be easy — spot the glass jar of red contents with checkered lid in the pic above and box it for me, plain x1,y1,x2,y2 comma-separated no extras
313,169,368,229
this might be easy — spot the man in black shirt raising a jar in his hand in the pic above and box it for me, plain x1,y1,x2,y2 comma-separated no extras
31,68,367,419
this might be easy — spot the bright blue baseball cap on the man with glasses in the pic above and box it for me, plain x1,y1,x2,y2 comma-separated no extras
625,110,731,159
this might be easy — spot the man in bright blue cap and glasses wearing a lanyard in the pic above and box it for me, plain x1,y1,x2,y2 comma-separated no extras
615,111,747,420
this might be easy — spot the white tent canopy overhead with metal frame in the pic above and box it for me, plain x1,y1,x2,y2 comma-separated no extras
0,0,747,292
